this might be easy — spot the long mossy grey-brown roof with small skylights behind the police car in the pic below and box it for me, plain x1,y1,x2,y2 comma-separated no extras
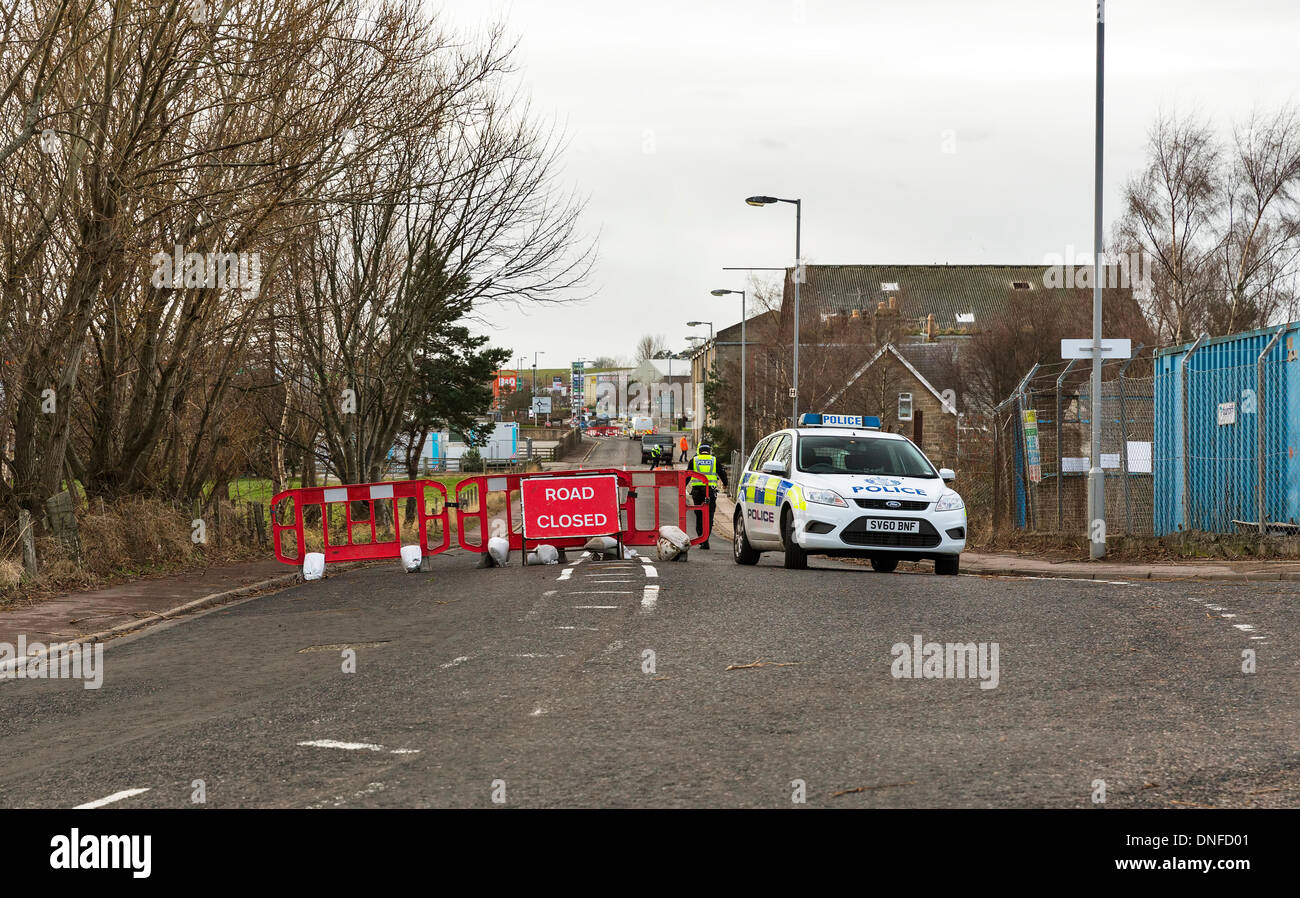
783,265,1132,333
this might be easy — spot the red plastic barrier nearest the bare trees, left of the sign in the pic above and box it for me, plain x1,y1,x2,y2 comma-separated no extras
270,480,449,564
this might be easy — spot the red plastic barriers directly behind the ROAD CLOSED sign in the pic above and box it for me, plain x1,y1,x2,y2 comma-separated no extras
455,468,709,552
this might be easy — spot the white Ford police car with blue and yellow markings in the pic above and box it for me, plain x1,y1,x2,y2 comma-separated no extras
733,413,966,574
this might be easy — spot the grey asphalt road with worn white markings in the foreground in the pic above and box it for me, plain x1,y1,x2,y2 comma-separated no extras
0,441,1300,808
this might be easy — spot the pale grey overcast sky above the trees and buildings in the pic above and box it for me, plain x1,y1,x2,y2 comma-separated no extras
430,0,1300,366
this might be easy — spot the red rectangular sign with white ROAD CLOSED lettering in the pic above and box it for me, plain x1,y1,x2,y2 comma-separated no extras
519,474,623,539
